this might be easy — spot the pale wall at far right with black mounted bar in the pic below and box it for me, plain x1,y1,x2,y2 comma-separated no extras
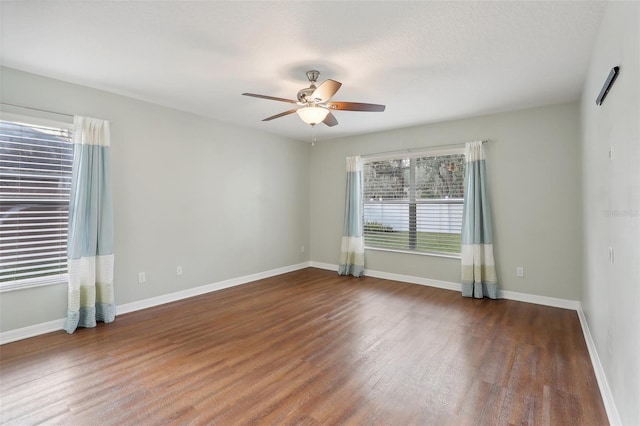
581,2,640,425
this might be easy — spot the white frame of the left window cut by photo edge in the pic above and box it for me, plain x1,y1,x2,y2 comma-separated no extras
0,111,73,293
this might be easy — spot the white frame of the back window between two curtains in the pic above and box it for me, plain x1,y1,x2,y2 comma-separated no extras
362,146,466,259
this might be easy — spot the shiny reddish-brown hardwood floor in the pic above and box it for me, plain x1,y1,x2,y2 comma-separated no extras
0,268,608,425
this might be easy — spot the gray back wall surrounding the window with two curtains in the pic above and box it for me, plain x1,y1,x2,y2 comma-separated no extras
310,103,582,300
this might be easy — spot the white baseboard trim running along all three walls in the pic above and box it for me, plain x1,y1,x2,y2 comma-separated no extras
0,261,621,425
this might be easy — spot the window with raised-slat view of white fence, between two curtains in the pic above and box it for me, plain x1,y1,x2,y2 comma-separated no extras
363,150,465,256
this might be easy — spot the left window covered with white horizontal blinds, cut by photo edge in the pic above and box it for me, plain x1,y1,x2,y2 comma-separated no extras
0,116,73,290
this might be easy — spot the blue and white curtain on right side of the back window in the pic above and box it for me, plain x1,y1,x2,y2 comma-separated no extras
461,142,498,299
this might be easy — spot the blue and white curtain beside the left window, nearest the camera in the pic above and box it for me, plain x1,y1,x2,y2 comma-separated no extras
64,116,115,333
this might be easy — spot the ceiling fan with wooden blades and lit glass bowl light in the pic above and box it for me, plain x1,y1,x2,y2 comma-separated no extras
243,70,385,127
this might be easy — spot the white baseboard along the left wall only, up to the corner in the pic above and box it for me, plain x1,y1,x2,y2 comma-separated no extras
0,262,310,345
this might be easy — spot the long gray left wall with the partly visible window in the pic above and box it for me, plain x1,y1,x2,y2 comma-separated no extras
0,68,309,331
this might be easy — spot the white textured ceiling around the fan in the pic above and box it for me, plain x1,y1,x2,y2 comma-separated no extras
0,0,606,141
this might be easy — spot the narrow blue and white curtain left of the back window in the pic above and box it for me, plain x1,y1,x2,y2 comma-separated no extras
338,156,364,277
